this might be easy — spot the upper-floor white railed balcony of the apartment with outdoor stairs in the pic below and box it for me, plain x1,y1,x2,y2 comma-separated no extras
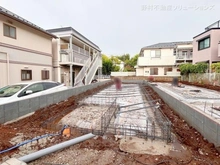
60,43,90,66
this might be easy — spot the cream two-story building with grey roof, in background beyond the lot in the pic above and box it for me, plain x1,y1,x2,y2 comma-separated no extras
136,41,193,76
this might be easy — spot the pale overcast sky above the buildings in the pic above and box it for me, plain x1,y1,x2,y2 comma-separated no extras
0,0,220,56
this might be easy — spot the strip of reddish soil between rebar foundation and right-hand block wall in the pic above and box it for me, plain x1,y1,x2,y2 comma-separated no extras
147,87,220,164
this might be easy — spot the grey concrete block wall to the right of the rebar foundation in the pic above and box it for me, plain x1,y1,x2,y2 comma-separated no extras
148,84,220,147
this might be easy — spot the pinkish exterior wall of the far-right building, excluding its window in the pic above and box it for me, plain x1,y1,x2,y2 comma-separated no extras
193,29,220,64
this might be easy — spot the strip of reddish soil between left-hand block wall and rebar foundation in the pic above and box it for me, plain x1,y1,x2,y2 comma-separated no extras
0,83,112,162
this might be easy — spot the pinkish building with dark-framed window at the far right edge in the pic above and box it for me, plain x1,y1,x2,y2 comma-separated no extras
193,21,220,69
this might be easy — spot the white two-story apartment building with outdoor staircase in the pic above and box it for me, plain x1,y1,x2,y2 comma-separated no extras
47,27,102,86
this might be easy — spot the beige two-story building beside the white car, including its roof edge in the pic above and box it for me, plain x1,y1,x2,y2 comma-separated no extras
0,6,56,87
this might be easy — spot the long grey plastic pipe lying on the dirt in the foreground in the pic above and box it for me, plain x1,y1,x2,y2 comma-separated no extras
18,133,95,163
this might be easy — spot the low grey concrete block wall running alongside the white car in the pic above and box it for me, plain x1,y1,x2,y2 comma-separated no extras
0,80,111,124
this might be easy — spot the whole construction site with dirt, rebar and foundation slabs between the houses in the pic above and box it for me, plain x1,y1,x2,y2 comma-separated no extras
0,81,220,165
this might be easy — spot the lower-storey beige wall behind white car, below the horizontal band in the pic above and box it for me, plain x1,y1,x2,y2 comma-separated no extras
0,46,52,87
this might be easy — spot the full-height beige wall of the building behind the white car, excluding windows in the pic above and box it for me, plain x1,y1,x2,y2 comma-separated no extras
0,14,53,87
